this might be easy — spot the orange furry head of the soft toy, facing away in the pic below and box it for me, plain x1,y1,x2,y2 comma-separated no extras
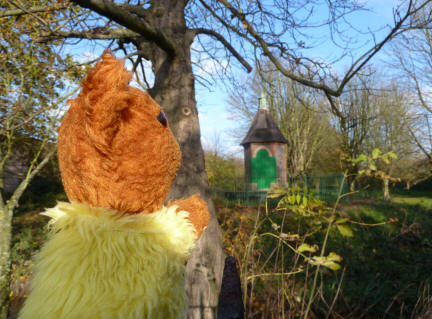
58,53,181,214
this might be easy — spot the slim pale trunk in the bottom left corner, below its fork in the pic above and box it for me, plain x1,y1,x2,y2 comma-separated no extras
0,208,12,319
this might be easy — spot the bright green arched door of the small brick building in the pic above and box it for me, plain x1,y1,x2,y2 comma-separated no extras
251,149,276,189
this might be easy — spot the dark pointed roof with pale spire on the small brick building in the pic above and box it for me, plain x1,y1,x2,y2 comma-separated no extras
240,93,288,145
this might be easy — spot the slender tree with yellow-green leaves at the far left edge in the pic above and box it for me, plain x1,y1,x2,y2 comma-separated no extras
0,1,81,319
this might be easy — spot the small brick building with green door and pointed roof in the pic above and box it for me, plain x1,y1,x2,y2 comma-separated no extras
241,93,287,190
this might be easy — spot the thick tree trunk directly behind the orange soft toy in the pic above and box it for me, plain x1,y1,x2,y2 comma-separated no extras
144,1,225,319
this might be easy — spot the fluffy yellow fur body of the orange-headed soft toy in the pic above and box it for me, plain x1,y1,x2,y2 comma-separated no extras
19,203,196,319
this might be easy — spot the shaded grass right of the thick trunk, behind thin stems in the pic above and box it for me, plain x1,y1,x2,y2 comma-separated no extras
218,194,432,318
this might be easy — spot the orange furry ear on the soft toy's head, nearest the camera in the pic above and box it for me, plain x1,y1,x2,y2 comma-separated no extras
77,52,132,153
